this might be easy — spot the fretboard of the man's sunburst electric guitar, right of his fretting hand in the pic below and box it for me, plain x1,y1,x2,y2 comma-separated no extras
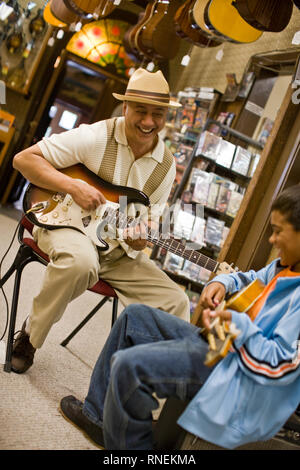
147,232,219,272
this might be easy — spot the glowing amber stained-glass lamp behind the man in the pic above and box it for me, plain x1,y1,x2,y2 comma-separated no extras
67,19,136,77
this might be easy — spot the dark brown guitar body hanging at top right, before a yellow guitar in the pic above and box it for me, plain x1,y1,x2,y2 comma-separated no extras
232,0,293,33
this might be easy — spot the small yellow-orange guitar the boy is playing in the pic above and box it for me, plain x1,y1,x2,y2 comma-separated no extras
202,279,265,367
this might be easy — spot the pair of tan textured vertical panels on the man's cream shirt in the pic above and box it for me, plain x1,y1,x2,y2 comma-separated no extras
98,118,174,197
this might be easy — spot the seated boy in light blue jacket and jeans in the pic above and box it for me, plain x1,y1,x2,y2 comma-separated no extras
61,185,300,450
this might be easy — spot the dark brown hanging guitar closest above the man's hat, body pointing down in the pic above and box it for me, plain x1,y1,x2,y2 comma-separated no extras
140,0,181,60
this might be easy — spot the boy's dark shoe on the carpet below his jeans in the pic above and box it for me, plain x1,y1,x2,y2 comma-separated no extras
60,395,104,449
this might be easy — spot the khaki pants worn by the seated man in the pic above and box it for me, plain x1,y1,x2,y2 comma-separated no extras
29,228,190,348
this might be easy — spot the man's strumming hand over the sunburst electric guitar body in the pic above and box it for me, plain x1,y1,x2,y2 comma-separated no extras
69,180,106,211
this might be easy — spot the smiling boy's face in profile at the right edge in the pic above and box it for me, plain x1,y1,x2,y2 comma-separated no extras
269,210,300,271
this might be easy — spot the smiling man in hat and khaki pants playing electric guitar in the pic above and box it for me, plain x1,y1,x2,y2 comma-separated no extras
12,69,189,373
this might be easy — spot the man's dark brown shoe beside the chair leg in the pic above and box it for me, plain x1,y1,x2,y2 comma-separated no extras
11,320,36,374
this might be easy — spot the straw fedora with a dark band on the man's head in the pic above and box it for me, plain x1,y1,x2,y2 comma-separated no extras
113,68,181,108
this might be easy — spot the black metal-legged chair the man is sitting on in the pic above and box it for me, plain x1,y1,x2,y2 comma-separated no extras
0,216,118,372
